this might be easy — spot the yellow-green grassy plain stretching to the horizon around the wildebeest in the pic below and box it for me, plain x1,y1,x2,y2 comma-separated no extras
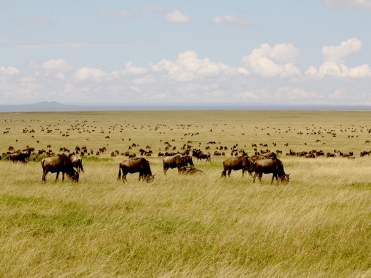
0,111,371,277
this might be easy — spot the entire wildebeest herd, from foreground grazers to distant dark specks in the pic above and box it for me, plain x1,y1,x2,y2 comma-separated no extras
1,111,371,184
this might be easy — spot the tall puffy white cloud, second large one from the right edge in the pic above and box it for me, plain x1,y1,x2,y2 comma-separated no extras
242,43,301,77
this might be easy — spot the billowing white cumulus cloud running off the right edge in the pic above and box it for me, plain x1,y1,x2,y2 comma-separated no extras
306,38,371,78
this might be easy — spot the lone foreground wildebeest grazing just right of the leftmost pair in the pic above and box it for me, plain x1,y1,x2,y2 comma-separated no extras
118,157,155,182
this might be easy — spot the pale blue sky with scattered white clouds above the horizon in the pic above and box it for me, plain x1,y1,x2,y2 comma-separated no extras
0,0,371,106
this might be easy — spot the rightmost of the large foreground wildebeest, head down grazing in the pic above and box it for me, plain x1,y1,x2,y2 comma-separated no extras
253,158,290,184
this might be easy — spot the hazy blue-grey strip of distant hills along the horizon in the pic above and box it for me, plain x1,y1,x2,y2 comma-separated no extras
0,101,371,112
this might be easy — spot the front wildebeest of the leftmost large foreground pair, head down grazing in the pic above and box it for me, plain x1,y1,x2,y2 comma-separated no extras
41,154,79,182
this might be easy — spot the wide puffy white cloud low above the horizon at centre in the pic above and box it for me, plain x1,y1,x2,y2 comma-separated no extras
151,51,248,82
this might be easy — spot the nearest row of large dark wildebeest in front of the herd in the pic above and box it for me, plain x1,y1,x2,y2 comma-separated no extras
0,148,289,184
